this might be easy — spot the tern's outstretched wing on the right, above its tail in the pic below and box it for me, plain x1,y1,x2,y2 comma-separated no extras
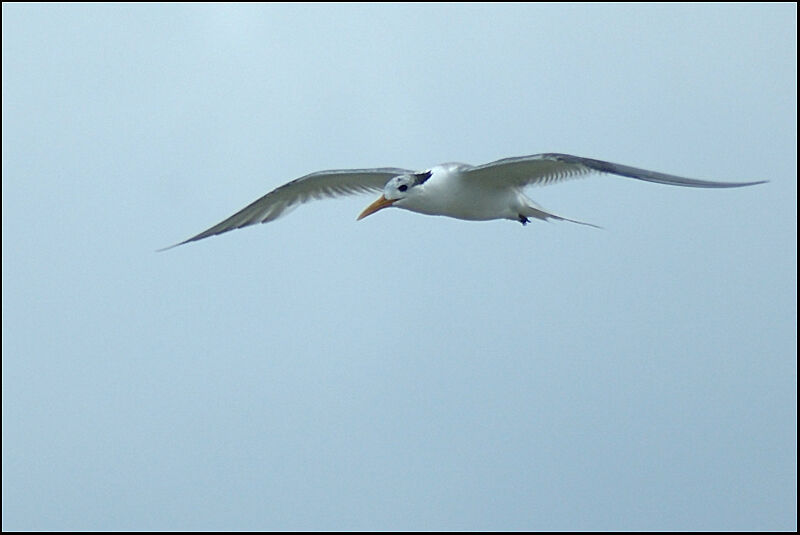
464,153,766,188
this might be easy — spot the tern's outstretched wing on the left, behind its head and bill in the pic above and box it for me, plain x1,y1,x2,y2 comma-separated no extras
161,167,411,251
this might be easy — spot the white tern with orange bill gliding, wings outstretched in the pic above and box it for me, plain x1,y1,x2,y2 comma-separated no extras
161,153,767,250
